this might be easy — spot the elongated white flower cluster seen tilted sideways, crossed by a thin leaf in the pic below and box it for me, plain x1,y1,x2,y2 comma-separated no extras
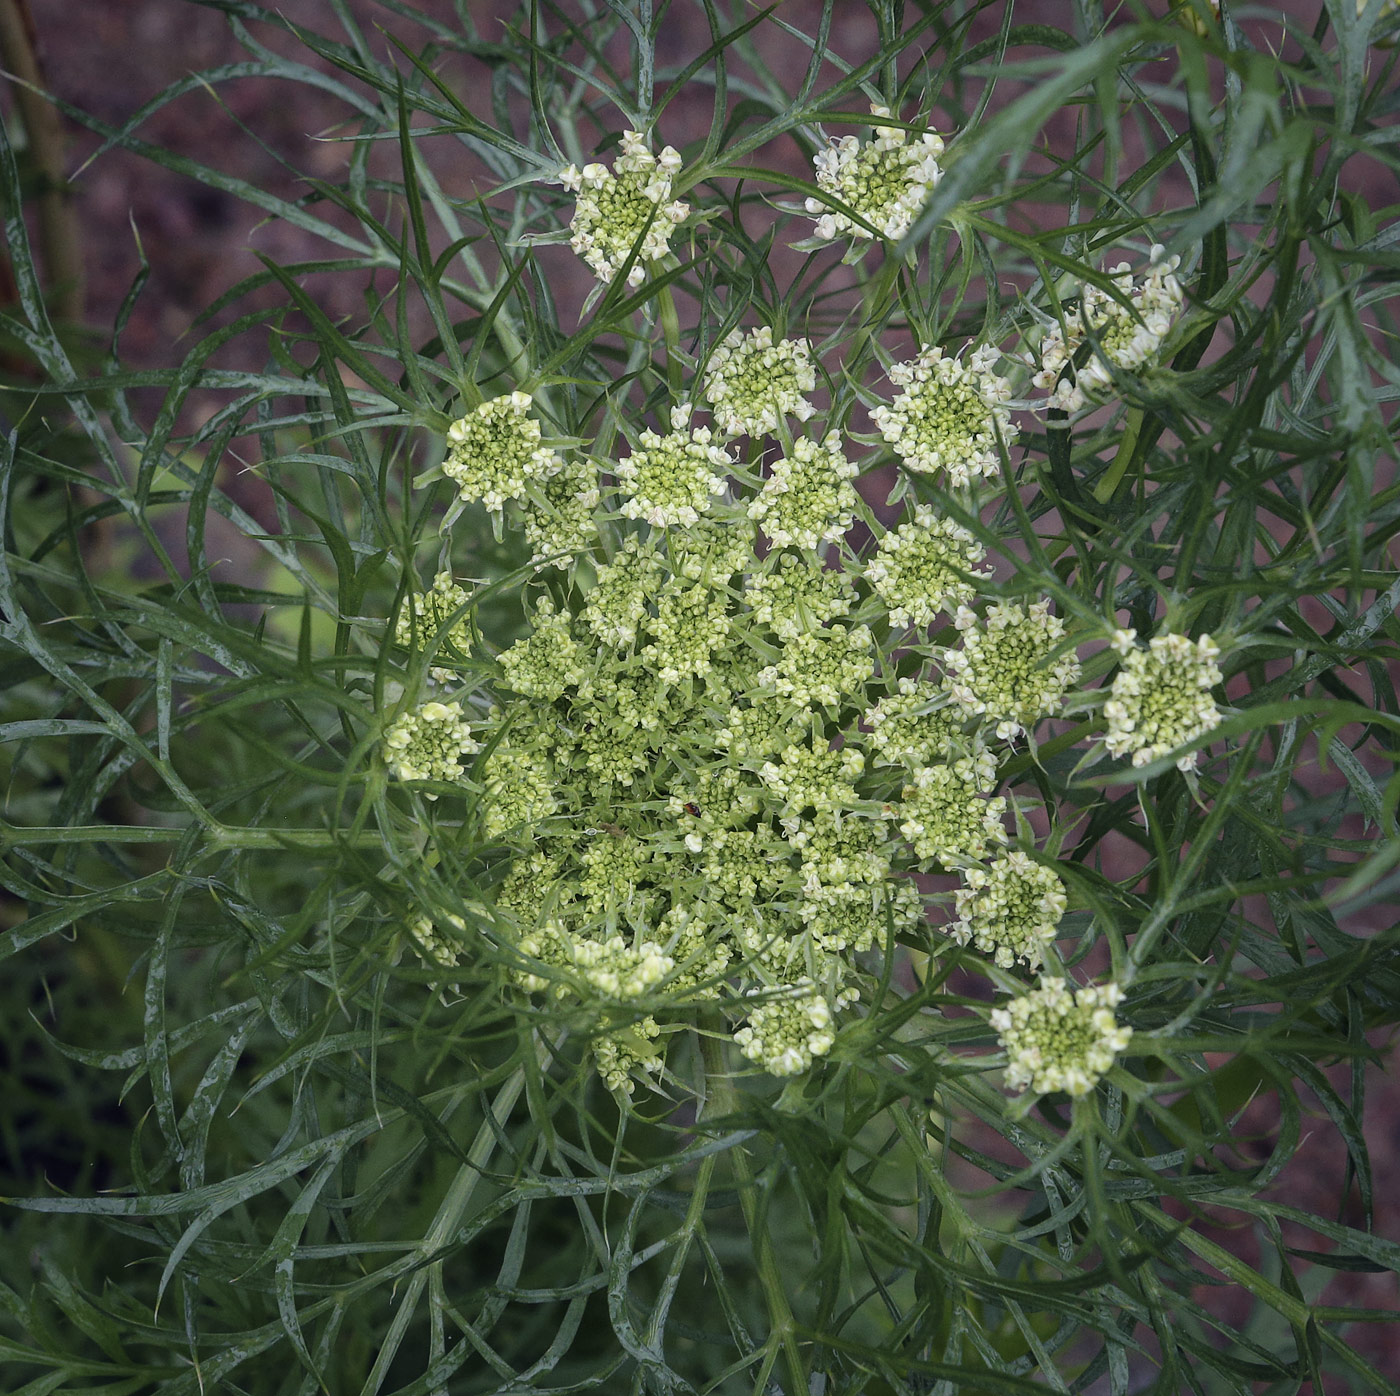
1030,245,1183,412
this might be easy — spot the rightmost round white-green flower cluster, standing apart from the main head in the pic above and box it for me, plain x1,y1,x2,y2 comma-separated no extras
1103,630,1224,770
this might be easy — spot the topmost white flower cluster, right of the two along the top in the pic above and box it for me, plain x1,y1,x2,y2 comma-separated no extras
806,106,944,242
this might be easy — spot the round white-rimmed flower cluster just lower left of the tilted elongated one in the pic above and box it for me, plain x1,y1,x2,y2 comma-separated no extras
871,344,1015,487
